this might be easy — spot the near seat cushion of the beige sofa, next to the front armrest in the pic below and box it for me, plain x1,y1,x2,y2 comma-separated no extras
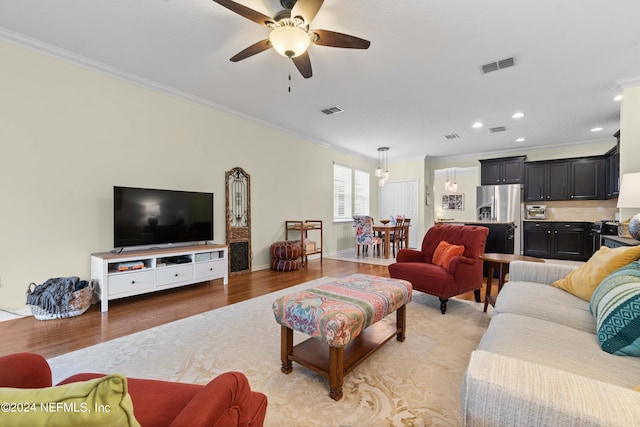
478,312,640,389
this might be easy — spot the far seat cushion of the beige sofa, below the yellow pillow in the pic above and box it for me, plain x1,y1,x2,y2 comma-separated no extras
493,282,596,334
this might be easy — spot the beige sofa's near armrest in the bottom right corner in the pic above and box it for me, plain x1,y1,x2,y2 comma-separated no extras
462,350,640,426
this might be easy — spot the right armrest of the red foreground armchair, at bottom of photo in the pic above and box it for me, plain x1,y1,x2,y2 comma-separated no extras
171,372,267,427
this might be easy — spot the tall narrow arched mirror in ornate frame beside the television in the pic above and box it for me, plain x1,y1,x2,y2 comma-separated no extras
225,168,251,275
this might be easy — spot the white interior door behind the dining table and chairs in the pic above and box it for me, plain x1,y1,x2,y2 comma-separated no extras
378,180,419,248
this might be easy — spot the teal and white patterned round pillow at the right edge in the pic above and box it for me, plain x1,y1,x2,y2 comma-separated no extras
589,261,640,356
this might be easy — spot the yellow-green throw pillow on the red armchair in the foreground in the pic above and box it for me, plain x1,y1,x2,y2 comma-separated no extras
0,374,140,427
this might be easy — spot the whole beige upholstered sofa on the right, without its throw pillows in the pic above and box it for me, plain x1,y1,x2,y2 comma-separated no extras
462,261,640,426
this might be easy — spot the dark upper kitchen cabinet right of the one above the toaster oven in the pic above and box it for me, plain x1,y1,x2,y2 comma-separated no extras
569,156,606,200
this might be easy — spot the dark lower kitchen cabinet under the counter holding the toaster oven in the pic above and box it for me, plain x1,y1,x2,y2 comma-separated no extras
523,221,592,261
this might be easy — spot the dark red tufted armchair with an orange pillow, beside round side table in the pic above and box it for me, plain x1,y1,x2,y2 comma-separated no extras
389,225,489,314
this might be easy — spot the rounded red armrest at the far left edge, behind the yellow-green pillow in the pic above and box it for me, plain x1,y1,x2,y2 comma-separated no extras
0,353,52,388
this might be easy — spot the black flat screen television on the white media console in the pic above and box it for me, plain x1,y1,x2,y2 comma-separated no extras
113,186,213,248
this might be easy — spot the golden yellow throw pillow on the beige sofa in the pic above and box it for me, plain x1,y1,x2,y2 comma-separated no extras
552,246,640,301
